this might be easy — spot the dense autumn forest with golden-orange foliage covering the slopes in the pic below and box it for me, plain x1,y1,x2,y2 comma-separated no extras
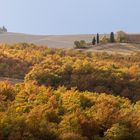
0,43,140,140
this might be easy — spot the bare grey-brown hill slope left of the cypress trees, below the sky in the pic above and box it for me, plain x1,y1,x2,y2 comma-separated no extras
0,32,93,48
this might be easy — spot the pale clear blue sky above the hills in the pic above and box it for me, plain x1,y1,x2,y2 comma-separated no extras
0,0,140,35
